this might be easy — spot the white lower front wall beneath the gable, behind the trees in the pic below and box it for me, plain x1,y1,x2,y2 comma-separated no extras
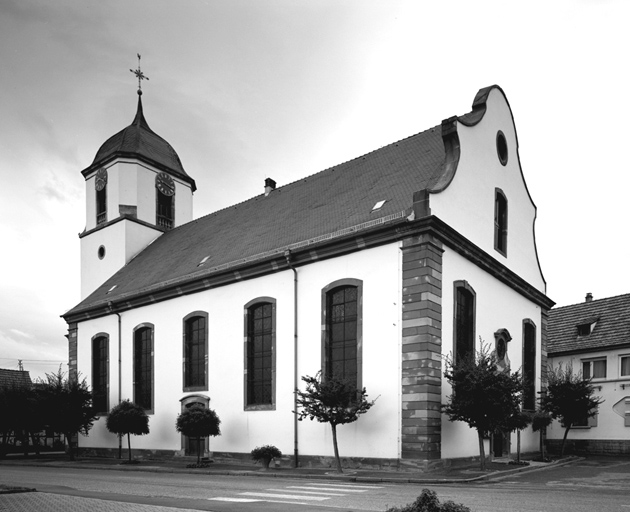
442,248,541,458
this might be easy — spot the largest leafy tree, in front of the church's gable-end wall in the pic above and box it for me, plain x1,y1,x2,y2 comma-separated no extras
442,341,523,470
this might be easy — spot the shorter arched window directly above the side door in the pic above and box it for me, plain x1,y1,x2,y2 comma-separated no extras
184,311,208,391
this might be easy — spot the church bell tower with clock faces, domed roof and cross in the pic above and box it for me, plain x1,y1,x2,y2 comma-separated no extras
79,55,196,300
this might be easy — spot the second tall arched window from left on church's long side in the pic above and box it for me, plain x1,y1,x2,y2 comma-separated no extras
133,324,153,411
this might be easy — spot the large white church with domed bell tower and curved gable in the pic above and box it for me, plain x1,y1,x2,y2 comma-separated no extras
63,86,553,465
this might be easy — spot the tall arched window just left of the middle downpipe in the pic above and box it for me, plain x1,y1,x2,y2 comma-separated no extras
245,297,276,410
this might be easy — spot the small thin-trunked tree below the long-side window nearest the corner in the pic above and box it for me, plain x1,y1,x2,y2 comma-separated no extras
295,371,376,473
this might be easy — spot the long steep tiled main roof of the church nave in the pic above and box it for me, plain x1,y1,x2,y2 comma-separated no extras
66,126,445,315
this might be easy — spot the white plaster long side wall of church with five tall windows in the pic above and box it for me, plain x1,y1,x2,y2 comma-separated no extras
78,244,400,458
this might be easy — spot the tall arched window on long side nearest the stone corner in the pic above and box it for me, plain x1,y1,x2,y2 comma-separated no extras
326,286,358,384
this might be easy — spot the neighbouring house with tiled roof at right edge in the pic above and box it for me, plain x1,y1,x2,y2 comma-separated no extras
547,293,630,455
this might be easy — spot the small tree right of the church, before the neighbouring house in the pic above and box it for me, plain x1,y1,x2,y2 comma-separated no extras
540,364,603,457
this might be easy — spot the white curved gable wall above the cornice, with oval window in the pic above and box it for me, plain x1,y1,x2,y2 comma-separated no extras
430,89,545,292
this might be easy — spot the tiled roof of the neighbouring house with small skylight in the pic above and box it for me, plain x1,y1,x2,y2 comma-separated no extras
548,294,630,355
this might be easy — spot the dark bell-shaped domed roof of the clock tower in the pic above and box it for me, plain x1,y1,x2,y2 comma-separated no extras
83,96,196,191
